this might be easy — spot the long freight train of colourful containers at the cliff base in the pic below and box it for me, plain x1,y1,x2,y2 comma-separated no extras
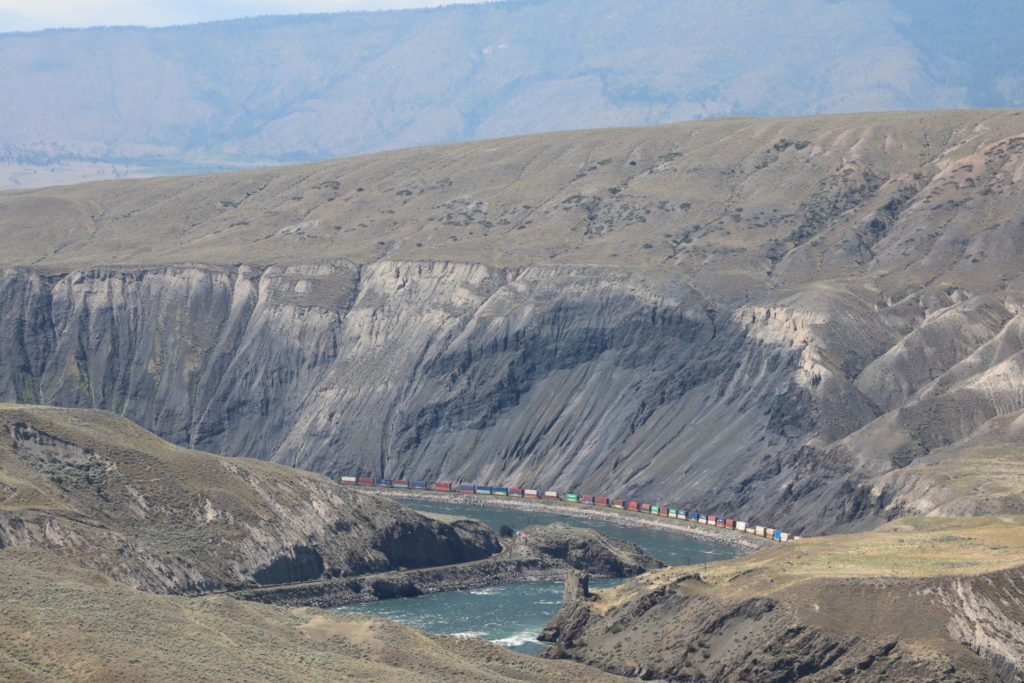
339,476,800,543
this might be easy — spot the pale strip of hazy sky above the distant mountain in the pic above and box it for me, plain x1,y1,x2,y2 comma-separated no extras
0,0,480,33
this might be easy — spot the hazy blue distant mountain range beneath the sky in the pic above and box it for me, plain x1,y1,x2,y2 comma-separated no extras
0,0,1024,187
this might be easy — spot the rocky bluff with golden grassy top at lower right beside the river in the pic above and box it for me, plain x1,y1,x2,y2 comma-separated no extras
543,518,1024,683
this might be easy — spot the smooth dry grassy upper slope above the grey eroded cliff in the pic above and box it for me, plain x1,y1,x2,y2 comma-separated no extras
0,111,1024,288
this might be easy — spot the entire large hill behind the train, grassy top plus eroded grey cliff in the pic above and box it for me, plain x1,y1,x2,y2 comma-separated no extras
6,112,1024,532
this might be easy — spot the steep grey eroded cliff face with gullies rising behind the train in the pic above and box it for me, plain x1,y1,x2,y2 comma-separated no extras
0,255,1024,530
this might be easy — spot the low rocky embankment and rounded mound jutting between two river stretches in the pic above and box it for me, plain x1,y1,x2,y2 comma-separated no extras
230,523,665,607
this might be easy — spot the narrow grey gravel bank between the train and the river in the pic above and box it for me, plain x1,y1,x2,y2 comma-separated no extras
382,487,774,550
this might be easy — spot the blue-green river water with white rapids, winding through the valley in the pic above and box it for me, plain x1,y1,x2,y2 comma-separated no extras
337,500,744,653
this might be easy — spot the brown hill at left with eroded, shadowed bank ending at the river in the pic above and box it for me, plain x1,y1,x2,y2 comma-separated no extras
0,407,500,593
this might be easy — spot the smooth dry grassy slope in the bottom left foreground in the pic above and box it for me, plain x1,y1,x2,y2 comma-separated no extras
0,548,622,683
